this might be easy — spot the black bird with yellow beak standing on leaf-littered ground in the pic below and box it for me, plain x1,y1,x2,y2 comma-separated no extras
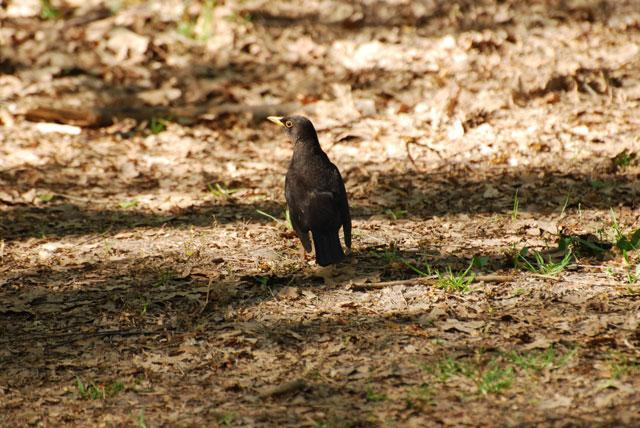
268,116,351,266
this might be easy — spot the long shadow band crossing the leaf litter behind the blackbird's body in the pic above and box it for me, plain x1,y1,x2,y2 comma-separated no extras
0,160,640,241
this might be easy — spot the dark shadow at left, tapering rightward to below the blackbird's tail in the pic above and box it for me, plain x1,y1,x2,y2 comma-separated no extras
0,247,500,368
